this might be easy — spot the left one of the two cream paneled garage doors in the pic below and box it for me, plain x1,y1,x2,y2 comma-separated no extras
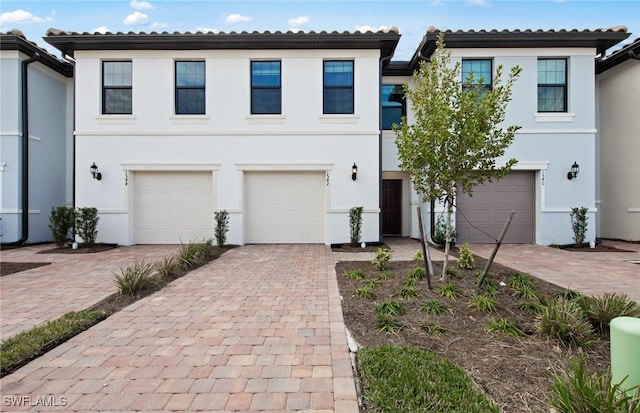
133,172,214,244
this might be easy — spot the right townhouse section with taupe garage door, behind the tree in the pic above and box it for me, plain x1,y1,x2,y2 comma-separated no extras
382,28,628,245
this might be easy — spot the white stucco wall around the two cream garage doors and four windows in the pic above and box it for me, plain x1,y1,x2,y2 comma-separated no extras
75,50,380,244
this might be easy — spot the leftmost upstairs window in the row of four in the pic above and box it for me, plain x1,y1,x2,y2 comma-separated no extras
102,62,132,115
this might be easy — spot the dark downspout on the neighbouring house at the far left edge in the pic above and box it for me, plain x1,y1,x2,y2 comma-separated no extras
1,52,40,246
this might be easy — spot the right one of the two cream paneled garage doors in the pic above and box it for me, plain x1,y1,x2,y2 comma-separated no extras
244,172,326,244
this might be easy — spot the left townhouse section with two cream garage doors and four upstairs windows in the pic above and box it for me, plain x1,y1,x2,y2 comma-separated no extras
45,30,400,245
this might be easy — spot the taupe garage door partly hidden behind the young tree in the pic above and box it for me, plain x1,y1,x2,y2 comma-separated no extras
456,171,535,244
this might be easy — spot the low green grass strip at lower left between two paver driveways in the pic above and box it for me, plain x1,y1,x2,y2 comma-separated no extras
0,310,107,376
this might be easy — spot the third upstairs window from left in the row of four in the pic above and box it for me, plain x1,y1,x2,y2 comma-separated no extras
251,61,282,115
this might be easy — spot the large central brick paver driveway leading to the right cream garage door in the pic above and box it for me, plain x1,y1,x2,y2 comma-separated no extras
0,245,358,412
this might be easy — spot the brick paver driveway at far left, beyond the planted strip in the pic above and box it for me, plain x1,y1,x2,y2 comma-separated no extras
0,244,178,340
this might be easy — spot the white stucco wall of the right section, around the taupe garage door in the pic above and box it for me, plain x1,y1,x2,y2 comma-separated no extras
382,48,596,245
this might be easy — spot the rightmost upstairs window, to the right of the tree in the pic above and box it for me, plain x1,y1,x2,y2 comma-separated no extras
538,59,567,112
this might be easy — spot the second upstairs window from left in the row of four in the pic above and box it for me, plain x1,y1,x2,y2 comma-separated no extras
176,62,205,115
